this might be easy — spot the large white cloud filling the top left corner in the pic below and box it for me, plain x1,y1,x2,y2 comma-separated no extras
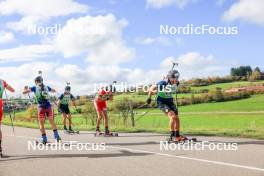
0,0,88,33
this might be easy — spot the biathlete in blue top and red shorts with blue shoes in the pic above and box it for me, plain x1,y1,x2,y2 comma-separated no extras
23,76,61,144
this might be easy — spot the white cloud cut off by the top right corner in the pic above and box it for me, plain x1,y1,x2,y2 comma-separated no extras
222,0,264,25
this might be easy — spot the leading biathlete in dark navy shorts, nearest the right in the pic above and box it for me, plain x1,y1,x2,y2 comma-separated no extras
147,70,187,142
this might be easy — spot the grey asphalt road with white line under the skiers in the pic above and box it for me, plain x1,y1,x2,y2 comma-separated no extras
0,126,264,176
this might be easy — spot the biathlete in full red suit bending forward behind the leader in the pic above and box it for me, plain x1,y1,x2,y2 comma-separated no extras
94,85,113,136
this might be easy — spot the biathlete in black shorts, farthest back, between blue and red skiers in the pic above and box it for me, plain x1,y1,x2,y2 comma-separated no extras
57,85,77,133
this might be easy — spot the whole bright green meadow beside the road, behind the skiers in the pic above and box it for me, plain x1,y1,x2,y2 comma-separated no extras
4,95,264,139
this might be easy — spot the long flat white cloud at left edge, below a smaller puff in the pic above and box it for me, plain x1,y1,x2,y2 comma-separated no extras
0,44,54,62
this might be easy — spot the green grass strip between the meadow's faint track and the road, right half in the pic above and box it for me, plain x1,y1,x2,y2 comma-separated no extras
137,114,264,139
